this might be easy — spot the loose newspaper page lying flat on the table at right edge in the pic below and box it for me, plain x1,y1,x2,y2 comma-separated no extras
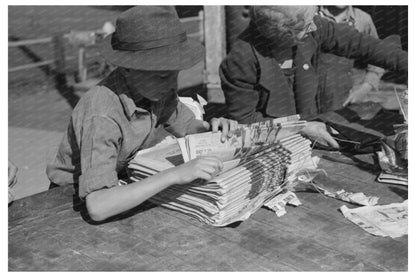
340,200,408,238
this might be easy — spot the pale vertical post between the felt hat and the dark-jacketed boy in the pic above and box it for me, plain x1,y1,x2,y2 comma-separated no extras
204,6,226,103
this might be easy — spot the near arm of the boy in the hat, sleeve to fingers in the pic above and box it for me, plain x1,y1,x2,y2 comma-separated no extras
79,113,220,221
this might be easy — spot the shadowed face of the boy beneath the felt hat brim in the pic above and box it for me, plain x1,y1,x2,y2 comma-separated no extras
122,68,179,101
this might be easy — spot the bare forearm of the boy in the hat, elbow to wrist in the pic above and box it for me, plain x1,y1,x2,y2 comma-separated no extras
86,170,179,221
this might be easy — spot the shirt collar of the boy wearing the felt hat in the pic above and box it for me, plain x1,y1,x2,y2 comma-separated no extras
100,68,149,120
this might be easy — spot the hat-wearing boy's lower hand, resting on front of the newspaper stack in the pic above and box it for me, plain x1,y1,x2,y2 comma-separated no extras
172,156,223,185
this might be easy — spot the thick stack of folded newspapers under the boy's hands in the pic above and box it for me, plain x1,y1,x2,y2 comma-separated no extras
129,113,315,226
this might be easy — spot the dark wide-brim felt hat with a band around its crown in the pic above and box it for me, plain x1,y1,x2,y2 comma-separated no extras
99,6,204,71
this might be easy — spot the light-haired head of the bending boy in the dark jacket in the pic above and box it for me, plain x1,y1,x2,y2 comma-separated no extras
251,6,317,47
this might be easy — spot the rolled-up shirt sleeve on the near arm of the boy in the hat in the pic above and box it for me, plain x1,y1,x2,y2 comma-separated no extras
79,116,121,198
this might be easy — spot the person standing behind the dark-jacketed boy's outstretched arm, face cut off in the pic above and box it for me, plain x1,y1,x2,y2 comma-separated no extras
317,6,384,109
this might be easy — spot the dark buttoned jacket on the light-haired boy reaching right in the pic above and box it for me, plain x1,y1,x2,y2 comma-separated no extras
219,16,408,123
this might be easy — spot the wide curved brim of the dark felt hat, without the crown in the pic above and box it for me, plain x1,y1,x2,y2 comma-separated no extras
99,35,204,71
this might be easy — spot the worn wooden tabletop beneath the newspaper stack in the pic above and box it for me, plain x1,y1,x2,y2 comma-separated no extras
9,153,408,271
